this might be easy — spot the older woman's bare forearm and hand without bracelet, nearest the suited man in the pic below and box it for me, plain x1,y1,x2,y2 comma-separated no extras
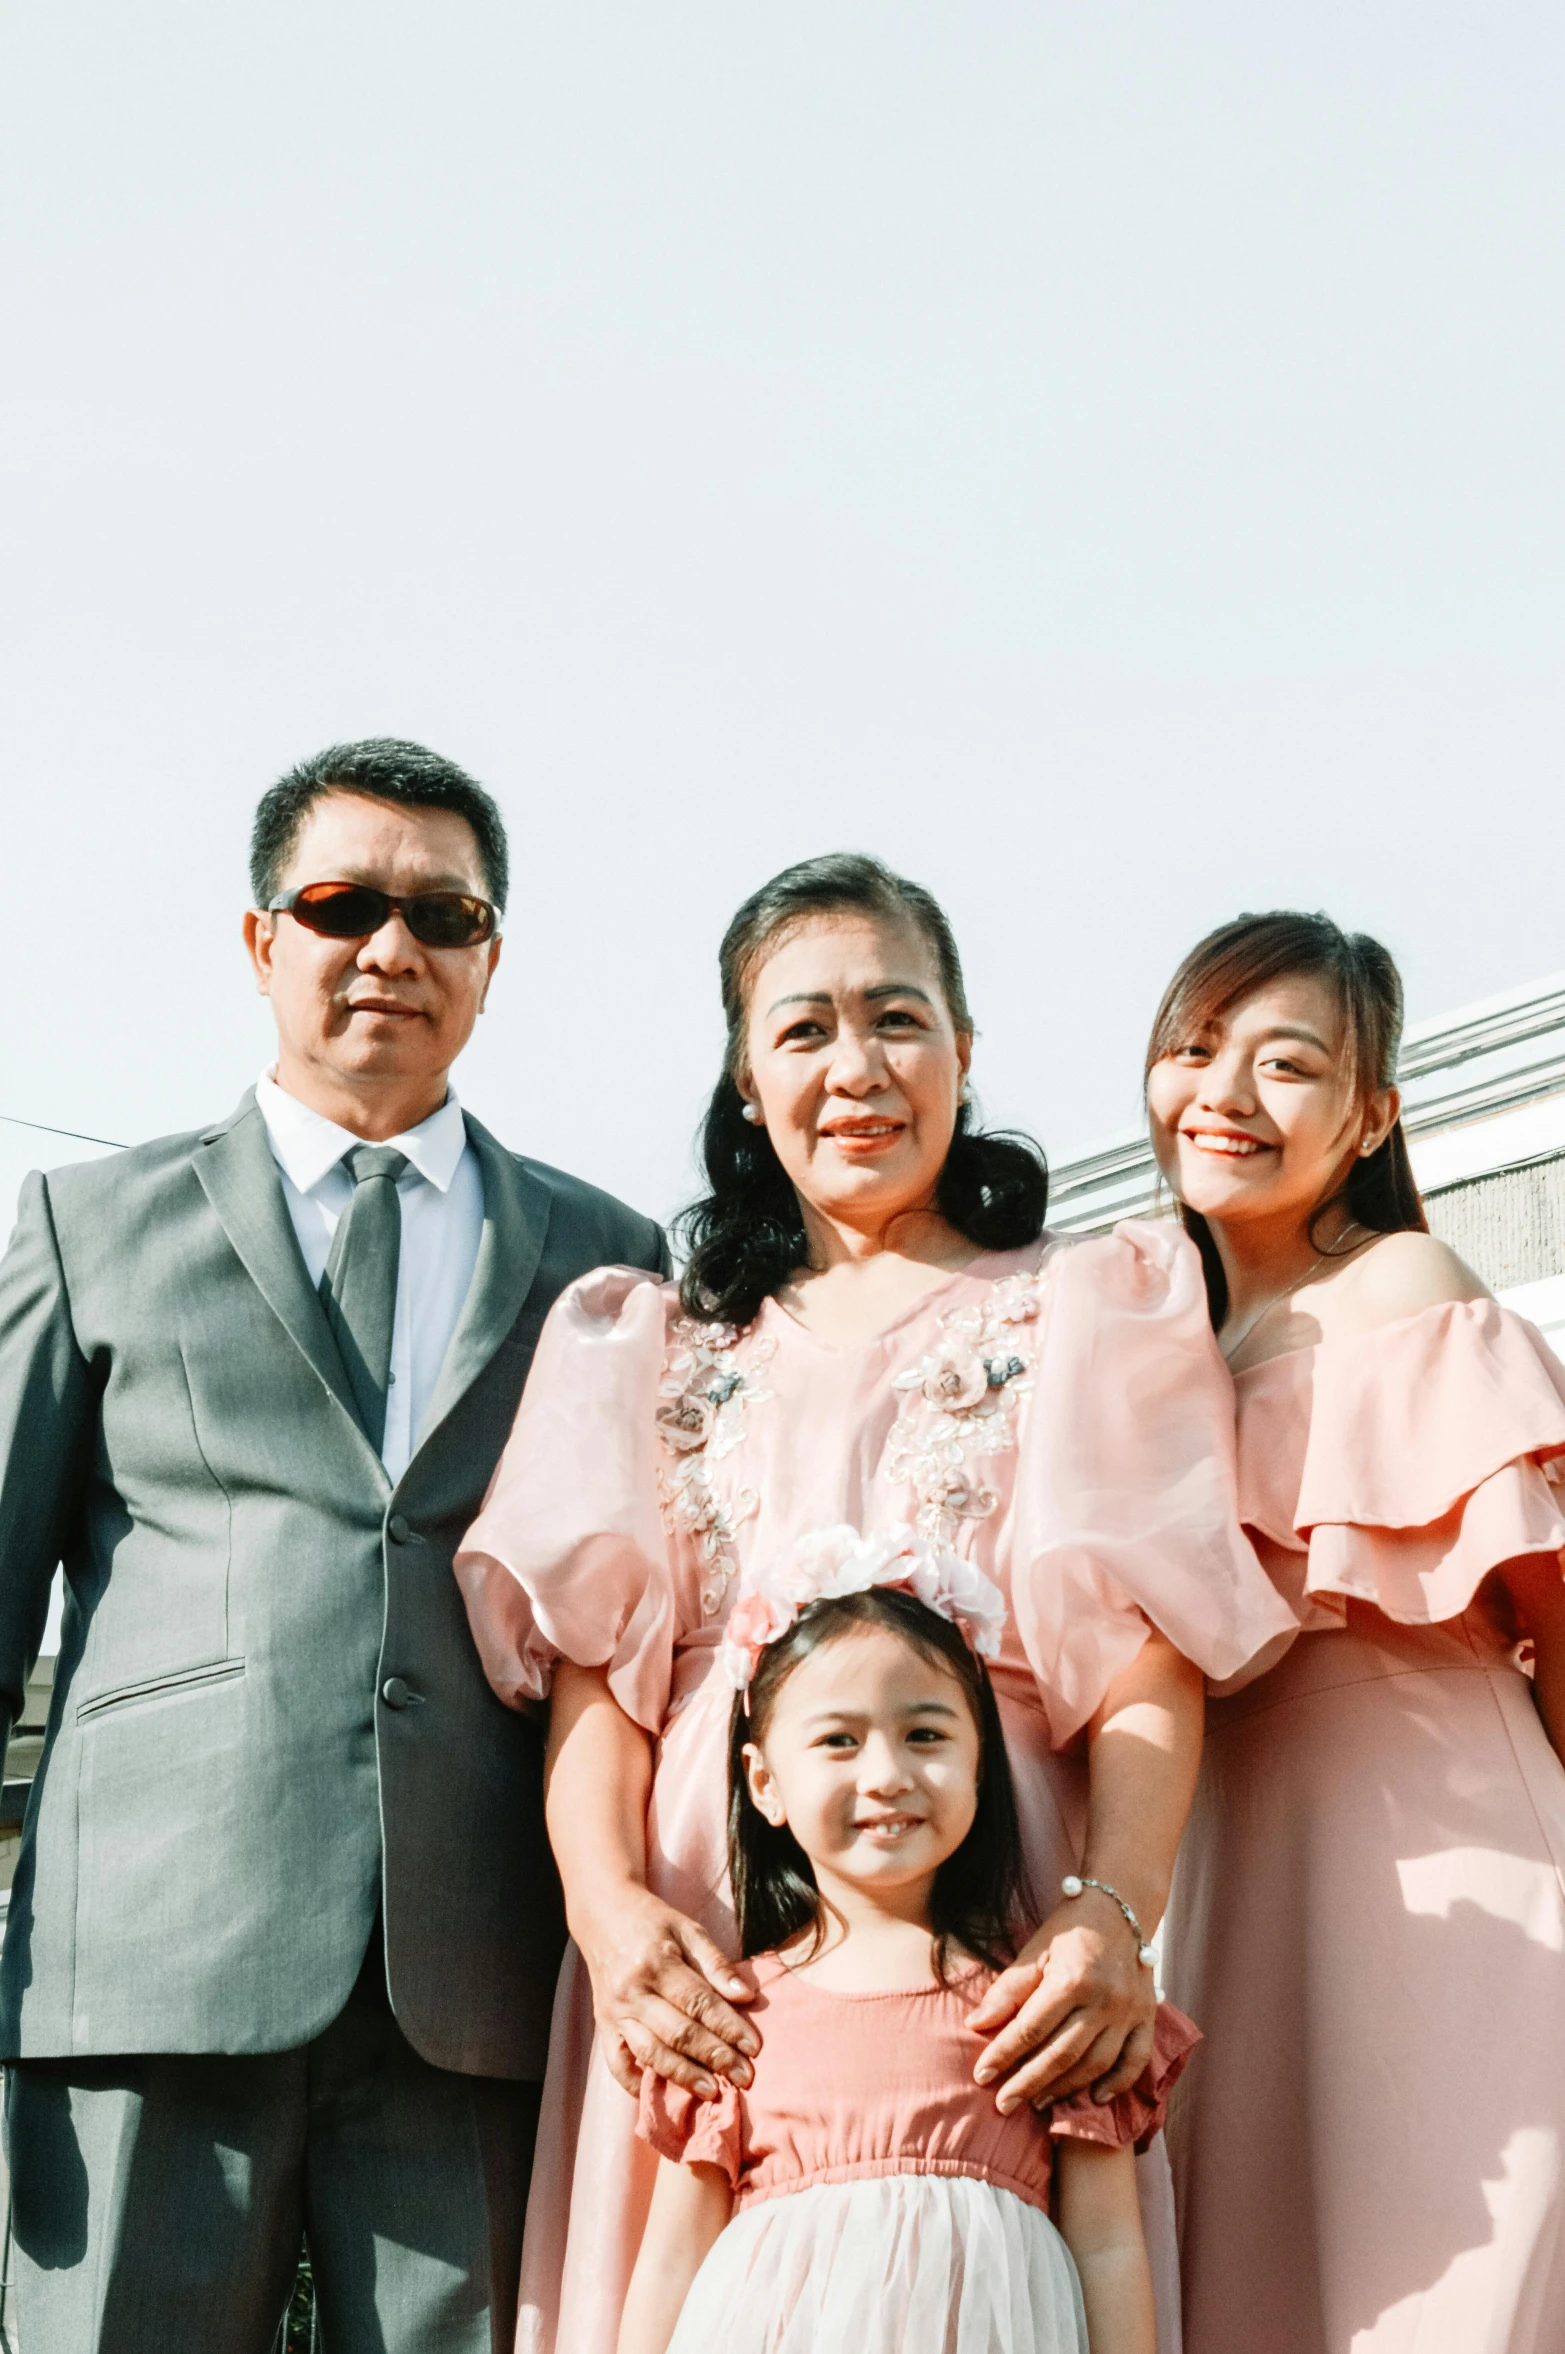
544,1660,760,2100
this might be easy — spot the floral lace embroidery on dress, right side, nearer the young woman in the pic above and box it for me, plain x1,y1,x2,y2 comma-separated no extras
887,1262,1047,1544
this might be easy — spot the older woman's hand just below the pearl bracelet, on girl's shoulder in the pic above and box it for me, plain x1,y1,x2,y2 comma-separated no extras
967,1888,1158,2109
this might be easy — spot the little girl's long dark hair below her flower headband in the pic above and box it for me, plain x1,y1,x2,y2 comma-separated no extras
727,1587,1033,1977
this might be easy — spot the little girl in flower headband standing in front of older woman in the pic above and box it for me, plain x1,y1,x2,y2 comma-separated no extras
619,1528,1196,2354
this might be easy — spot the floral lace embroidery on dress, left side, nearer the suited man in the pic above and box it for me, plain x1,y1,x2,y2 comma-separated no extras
654,1316,777,1617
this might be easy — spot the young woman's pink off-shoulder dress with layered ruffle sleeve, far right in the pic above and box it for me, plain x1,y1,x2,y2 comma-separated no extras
1165,1299,1565,2354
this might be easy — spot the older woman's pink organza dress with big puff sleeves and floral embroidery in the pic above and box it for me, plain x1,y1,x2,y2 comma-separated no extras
457,1224,1292,2354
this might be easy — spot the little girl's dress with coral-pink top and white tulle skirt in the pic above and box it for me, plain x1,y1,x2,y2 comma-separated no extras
638,1954,1198,2354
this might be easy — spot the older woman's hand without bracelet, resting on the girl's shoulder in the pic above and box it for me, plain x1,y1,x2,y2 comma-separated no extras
572,1881,760,2100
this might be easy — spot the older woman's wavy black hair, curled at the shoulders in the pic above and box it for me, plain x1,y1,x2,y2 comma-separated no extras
675,852,1050,1325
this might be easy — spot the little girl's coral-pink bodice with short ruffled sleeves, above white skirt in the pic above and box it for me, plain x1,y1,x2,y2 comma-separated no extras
635,1954,1200,2215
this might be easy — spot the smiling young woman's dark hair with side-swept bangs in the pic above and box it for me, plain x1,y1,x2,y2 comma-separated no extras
1146,909,1429,1330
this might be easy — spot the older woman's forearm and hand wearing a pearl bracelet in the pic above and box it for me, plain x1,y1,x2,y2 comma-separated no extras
972,1627,1205,2109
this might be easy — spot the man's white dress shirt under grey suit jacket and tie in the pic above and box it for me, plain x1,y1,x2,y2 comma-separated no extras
257,1073,482,1483
